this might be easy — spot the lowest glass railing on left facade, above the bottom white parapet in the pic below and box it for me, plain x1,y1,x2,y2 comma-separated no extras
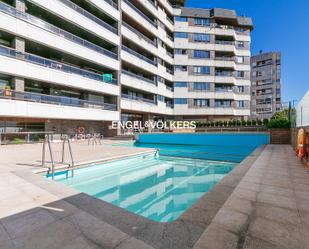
0,90,117,111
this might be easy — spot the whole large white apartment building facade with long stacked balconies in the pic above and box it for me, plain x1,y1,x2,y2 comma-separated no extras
0,0,252,133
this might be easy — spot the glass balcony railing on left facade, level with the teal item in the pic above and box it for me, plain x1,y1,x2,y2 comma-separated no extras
0,46,117,85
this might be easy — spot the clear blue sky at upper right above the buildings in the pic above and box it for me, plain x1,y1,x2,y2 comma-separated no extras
186,0,309,104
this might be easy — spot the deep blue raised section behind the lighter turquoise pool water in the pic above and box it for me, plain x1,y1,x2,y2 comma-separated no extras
114,133,269,162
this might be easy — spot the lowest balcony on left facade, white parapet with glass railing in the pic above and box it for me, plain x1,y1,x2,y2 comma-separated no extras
0,91,119,121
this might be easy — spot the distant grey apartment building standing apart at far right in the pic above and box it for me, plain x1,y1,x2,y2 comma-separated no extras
251,52,282,119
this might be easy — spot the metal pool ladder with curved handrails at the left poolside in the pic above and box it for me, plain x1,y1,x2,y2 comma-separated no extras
42,135,74,180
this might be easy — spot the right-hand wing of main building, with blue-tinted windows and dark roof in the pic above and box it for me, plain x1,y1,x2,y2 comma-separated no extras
174,8,253,120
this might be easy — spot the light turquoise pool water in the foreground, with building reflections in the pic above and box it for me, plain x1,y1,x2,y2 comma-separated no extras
52,155,236,222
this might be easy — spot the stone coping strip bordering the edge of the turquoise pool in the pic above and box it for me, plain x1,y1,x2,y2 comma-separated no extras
14,145,266,249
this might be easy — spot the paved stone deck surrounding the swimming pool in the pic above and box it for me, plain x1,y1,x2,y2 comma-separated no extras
0,141,309,249
